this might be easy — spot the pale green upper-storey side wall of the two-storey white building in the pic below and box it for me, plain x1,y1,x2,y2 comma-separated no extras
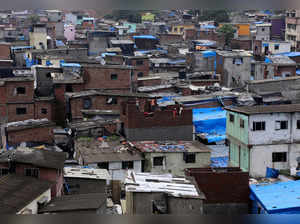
226,111,249,145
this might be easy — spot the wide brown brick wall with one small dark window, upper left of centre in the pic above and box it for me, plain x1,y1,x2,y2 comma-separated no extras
83,66,131,90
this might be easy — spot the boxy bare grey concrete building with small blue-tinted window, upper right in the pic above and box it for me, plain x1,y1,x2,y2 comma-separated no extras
217,50,252,87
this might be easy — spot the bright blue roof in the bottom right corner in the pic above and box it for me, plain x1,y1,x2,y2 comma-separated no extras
250,180,300,214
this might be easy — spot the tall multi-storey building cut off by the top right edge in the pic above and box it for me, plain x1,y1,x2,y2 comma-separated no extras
285,9,300,51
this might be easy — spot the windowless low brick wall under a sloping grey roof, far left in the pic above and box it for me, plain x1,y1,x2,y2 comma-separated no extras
7,126,53,145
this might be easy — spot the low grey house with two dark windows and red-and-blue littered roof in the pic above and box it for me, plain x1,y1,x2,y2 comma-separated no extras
132,141,211,176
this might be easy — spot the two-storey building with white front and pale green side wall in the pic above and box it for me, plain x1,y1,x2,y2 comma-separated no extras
226,104,300,177
